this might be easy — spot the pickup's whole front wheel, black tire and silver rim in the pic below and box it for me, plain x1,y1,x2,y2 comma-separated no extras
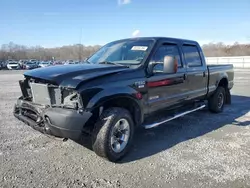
92,107,134,162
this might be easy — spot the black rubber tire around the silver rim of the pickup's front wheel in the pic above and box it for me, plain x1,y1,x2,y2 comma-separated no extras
92,107,134,162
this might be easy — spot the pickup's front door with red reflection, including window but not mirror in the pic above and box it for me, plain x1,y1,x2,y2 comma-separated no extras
147,42,188,113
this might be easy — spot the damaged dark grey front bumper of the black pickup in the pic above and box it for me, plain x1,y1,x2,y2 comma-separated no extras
14,98,92,140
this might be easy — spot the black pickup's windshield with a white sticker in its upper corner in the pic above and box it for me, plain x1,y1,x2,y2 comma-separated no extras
87,40,154,65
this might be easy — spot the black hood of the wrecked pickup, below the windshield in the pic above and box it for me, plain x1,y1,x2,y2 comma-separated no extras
24,64,128,88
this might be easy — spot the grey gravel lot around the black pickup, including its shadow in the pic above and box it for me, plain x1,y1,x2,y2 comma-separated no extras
0,70,250,188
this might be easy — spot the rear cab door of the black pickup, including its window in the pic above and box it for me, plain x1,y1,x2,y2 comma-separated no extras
182,43,208,100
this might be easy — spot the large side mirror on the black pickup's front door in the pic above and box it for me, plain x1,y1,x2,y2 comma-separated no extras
163,56,178,74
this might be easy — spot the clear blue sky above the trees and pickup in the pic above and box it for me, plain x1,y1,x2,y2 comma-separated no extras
0,0,250,47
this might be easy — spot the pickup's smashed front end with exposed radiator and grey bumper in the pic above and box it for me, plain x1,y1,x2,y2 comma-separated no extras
14,78,92,140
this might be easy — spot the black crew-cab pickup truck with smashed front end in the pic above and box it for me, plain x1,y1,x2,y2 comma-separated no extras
14,37,234,161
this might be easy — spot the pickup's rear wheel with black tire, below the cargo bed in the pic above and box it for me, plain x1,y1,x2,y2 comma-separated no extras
208,86,226,113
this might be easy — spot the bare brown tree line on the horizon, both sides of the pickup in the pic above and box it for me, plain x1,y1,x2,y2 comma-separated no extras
0,42,250,61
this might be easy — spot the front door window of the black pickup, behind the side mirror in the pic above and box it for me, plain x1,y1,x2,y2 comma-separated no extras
152,44,182,73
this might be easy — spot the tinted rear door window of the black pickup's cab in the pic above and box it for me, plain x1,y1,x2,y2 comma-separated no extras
182,44,202,67
